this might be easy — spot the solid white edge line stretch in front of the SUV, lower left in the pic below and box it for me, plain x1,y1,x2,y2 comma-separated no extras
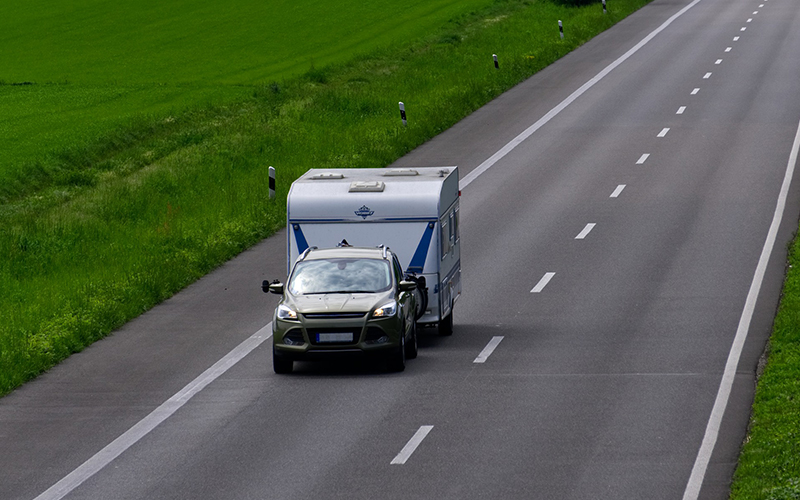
35,322,272,500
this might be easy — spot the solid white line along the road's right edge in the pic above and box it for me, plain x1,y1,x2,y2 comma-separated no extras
683,116,800,500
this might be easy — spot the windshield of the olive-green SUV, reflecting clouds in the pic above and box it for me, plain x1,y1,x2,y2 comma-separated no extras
289,259,392,295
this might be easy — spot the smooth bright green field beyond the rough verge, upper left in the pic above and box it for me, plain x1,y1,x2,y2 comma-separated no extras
0,0,492,201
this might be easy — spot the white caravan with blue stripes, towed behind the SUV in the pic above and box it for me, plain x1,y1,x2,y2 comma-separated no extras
286,167,461,335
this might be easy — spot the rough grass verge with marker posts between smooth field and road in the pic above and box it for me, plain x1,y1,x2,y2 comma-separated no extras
0,0,647,392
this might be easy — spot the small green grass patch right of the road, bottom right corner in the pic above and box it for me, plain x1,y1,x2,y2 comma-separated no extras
731,225,800,500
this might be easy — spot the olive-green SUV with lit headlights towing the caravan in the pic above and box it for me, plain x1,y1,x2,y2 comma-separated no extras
262,247,417,373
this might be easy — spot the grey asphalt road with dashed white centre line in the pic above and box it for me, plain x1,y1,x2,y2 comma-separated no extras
0,0,800,500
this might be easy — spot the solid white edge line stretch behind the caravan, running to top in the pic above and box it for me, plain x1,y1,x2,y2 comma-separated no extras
458,0,702,189
